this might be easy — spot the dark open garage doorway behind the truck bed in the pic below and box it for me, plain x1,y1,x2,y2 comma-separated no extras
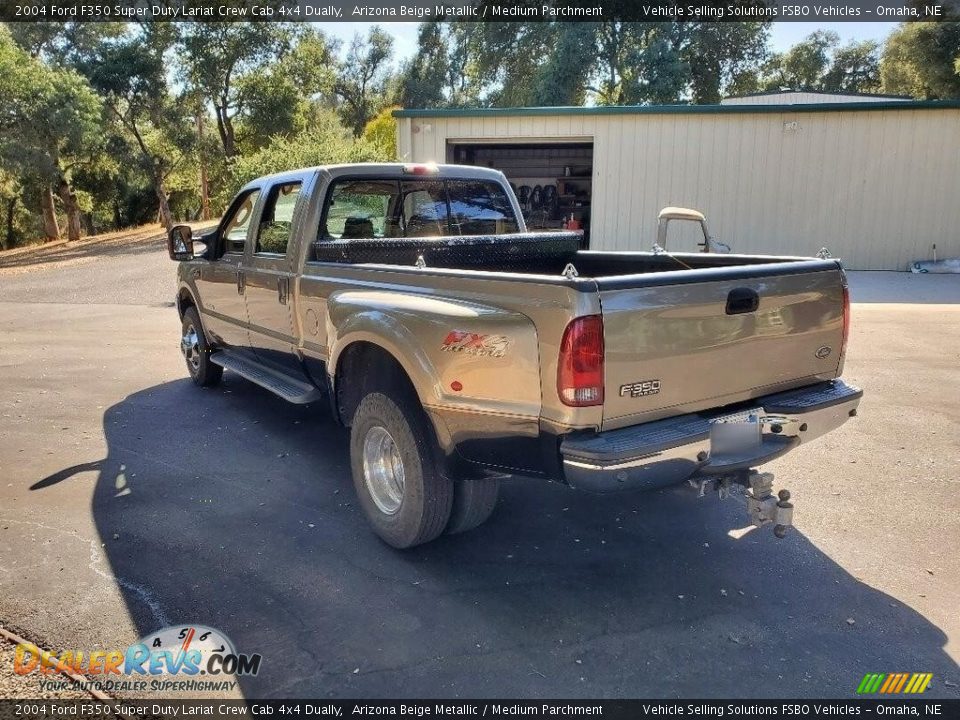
447,141,593,247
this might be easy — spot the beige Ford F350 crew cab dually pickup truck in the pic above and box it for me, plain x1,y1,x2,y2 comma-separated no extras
168,164,862,548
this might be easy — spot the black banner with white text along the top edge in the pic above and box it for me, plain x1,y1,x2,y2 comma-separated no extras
0,0,960,22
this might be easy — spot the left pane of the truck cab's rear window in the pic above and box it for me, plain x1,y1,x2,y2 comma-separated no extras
320,180,403,240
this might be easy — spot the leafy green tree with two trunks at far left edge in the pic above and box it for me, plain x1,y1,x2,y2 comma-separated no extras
0,31,102,240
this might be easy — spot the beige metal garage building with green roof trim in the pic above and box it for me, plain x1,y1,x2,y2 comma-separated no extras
394,99,960,270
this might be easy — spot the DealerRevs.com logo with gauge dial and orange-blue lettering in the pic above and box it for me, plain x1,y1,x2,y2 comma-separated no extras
13,625,262,690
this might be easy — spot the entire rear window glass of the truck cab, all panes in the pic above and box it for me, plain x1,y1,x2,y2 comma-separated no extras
320,179,518,241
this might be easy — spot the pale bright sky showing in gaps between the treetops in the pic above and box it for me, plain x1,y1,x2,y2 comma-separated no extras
317,22,898,60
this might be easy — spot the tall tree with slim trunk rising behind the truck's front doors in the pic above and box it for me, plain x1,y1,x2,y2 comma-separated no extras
179,22,293,158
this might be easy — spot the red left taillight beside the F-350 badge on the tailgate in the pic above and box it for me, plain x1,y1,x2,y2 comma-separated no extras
557,315,603,407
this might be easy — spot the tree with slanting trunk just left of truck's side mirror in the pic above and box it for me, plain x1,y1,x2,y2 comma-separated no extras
86,23,195,229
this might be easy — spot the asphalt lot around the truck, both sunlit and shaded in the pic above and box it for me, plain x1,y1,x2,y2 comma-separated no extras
0,233,960,698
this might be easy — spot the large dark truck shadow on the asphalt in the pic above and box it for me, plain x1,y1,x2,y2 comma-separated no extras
84,374,957,698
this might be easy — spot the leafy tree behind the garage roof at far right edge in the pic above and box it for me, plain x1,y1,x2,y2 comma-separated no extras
880,22,960,100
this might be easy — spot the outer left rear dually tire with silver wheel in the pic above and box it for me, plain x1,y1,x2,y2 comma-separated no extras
350,391,453,549
